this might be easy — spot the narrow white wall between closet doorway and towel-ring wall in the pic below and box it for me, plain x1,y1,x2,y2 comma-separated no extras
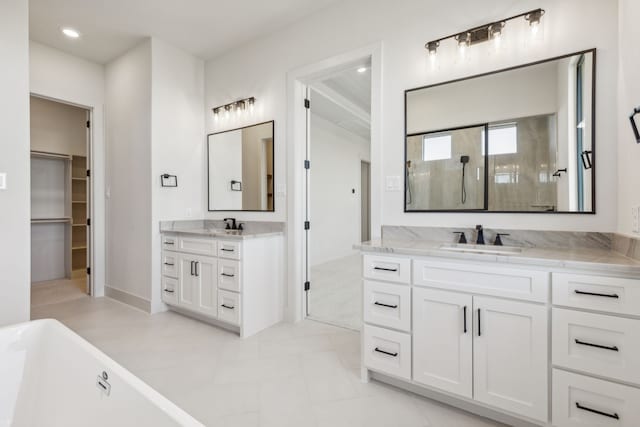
105,40,154,310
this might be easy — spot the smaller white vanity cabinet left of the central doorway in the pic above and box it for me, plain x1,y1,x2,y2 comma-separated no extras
162,233,284,337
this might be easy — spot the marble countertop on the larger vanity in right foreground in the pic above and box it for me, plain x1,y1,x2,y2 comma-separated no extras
354,239,640,278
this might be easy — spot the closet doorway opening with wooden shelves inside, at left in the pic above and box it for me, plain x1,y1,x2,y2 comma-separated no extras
30,95,92,308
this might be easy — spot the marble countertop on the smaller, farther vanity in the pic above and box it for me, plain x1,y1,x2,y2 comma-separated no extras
160,221,284,240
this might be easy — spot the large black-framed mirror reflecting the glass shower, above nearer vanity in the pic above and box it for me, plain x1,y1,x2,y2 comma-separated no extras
404,49,596,214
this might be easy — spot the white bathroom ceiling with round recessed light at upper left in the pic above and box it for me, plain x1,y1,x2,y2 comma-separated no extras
29,0,342,63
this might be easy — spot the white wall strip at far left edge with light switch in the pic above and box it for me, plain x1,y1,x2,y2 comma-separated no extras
0,0,31,325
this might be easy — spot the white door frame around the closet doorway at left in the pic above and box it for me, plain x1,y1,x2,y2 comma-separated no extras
29,91,96,297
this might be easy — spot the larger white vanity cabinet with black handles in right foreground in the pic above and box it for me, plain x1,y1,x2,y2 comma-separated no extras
362,252,640,427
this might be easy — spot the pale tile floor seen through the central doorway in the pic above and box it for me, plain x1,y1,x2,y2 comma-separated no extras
309,253,362,331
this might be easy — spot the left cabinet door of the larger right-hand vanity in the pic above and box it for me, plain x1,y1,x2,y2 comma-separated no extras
413,288,473,398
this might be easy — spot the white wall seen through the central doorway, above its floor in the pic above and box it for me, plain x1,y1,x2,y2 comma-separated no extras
310,114,370,266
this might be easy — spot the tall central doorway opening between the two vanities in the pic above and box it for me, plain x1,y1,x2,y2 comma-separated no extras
304,57,372,330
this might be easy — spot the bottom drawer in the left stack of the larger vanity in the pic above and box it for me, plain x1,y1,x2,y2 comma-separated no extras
363,325,411,380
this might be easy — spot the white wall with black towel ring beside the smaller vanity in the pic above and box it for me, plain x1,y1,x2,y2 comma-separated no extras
148,38,207,312
